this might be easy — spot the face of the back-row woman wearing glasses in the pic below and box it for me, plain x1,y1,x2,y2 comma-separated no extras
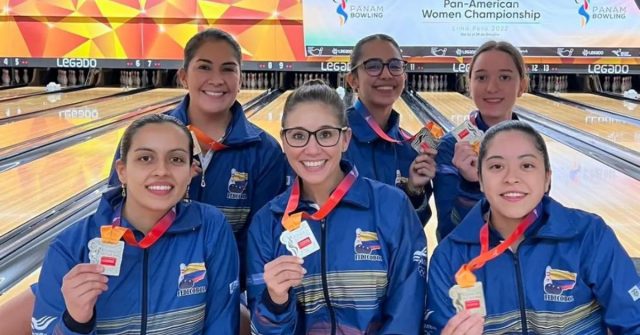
348,39,406,109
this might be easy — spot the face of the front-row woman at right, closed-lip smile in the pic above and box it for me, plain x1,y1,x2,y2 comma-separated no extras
480,130,551,225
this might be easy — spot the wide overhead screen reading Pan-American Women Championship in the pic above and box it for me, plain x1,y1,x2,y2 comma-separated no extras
303,0,640,57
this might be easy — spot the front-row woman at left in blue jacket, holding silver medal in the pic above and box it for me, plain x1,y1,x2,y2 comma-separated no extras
32,115,239,334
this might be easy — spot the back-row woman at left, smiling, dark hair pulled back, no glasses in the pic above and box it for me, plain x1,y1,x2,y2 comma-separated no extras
110,29,286,287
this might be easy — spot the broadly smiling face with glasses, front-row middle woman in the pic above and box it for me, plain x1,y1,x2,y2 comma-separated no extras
282,102,351,187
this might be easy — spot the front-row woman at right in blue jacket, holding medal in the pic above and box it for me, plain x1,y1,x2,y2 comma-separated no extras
425,121,640,334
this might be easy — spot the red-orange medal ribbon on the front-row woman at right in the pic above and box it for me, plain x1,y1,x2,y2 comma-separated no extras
456,206,540,287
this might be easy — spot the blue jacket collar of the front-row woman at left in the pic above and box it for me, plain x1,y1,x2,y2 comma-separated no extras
95,187,202,234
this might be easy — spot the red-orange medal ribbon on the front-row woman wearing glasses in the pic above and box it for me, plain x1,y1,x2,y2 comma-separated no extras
282,167,358,231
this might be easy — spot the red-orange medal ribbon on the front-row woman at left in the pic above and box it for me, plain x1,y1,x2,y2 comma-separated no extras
100,206,176,249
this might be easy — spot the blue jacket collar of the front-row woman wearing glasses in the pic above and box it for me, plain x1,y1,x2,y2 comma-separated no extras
269,160,370,214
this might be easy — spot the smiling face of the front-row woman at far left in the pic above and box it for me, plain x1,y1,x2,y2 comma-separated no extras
116,123,191,216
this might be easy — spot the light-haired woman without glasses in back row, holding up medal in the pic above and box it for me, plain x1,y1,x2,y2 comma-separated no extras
433,41,527,240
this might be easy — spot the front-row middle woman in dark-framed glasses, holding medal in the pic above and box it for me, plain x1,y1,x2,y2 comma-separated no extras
247,81,426,334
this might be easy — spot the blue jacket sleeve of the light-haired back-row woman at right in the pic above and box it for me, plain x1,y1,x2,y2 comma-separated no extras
433,136,483,241
